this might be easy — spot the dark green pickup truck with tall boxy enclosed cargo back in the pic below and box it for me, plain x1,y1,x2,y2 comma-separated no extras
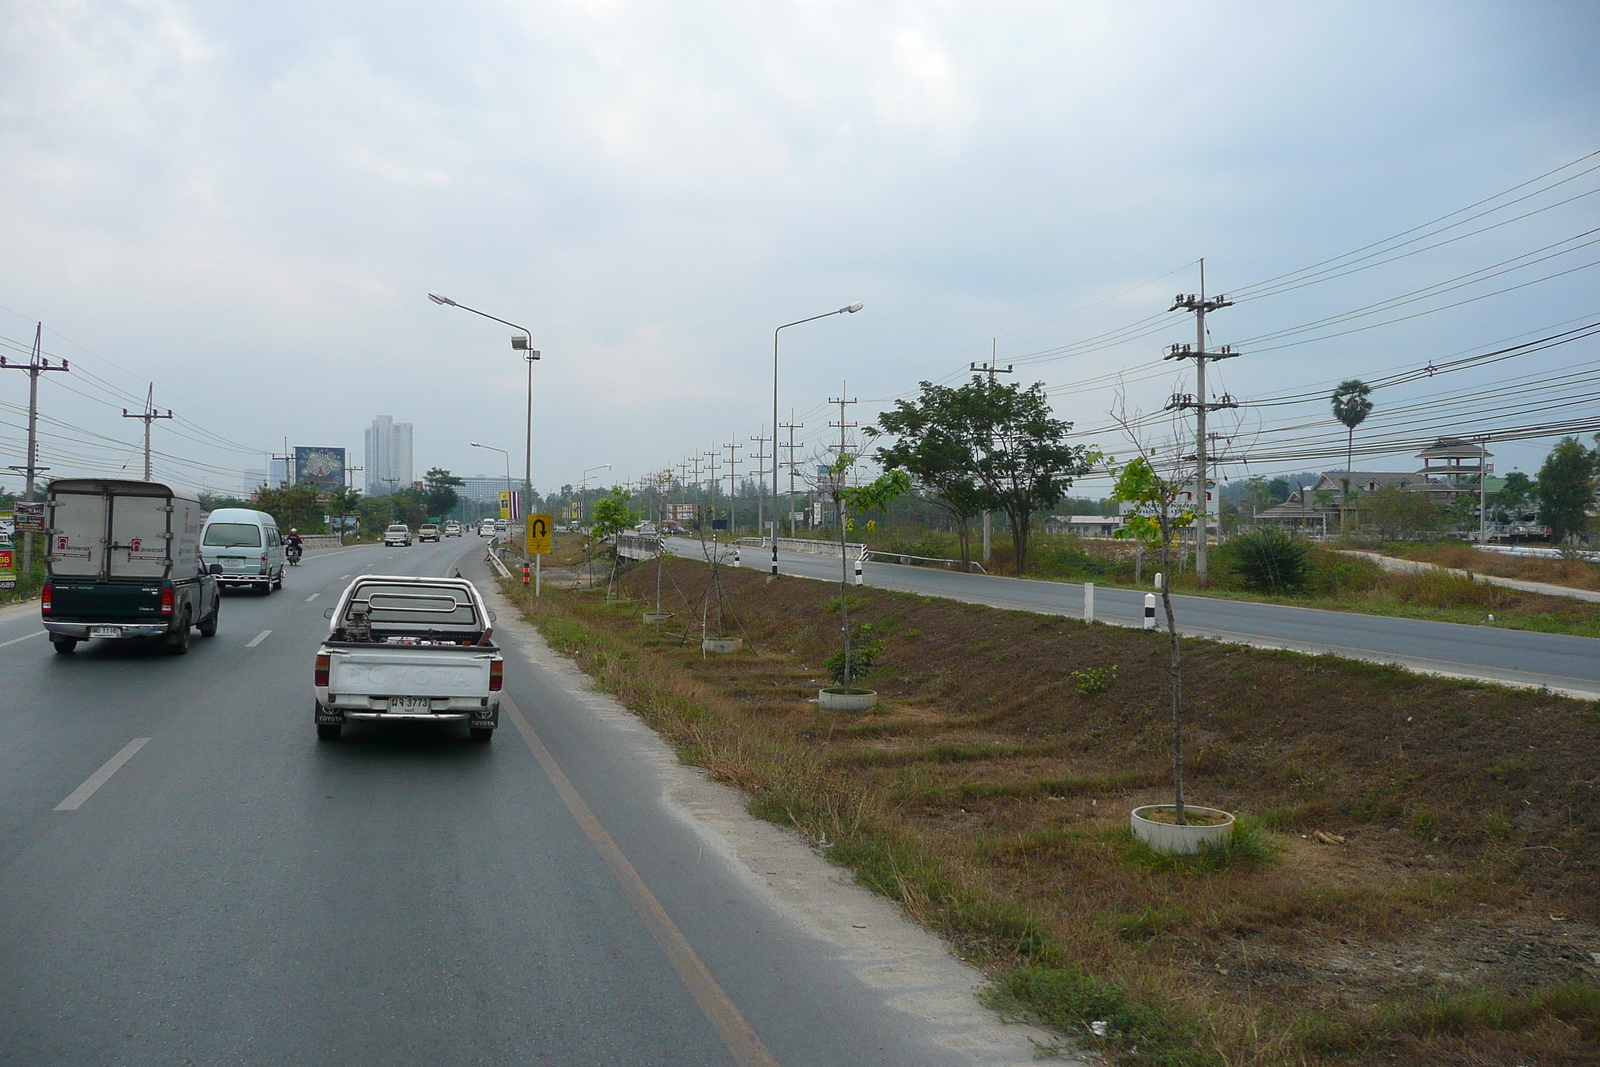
40,478,222,656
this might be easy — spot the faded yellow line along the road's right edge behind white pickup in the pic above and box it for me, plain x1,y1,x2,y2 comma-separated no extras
501,694,778,1067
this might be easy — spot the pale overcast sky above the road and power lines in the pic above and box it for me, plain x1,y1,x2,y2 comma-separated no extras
0,0,1600,502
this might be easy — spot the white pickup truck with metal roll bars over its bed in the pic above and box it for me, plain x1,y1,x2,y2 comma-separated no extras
312,574,506,741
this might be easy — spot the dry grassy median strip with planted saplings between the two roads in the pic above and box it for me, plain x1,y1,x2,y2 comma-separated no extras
506,559,1600,1067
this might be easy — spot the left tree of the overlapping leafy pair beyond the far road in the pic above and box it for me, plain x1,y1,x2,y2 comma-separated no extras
864,382,984,565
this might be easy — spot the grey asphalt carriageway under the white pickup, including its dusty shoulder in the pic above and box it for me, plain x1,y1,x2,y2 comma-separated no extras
0,537,1032,1067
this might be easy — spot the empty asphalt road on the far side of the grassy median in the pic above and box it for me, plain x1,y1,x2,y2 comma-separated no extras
684,537,1600,697
